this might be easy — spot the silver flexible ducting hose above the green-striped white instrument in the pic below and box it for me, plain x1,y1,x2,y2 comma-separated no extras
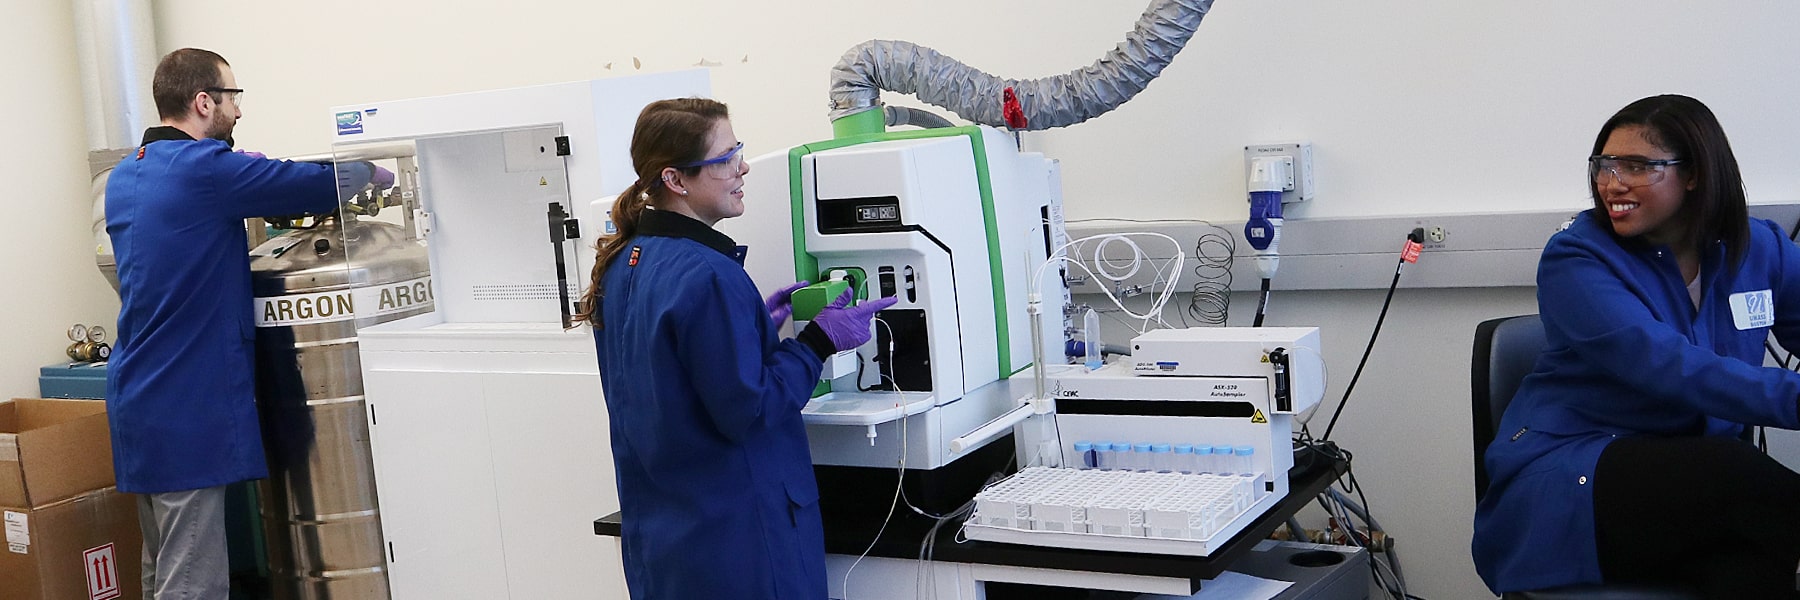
832,0,1213,130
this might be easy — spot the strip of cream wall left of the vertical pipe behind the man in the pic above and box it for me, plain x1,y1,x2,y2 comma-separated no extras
0,0,119,398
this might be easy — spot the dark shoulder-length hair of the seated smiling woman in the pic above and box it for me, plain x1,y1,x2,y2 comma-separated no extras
1588,94,1750,265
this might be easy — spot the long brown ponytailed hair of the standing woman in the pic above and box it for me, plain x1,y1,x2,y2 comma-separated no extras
574,97,731,330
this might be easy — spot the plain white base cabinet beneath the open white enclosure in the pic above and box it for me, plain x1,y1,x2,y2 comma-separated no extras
360,321,626,600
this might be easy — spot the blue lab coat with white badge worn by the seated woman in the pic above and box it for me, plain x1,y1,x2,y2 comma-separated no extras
1472,211,1800,593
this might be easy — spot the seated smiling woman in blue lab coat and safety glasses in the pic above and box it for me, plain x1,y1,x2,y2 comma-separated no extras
1474,95,1800,598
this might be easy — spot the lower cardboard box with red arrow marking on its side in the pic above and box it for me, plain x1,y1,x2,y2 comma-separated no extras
0,488,144,600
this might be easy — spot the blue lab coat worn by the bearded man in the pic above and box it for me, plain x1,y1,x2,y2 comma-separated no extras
106,126,354,494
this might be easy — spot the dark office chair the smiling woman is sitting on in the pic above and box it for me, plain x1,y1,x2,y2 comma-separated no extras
1469,315,1699,600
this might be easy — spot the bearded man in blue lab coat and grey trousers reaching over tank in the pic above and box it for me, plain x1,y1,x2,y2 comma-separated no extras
106,49,374,598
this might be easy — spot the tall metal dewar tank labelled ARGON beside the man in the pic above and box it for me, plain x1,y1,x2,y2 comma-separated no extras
250,216,434,600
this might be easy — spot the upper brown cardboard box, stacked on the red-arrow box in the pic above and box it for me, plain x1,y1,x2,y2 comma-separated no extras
0,398,113,508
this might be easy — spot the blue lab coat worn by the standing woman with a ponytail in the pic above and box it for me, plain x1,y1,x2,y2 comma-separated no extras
594,209,826,600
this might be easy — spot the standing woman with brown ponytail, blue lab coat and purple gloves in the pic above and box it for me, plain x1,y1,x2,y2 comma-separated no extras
581,97,893,598
